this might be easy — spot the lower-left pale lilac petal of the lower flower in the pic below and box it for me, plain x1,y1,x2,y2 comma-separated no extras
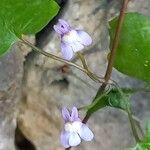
60,130,70,148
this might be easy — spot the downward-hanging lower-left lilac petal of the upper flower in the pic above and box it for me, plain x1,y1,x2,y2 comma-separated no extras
61,42,73,60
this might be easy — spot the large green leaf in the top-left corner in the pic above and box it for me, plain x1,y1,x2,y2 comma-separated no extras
0,0,59,55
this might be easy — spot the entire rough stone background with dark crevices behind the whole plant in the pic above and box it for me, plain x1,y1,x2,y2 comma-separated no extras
0,0,150,150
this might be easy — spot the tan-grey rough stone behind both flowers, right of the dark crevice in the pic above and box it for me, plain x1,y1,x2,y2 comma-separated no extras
18,0,150,150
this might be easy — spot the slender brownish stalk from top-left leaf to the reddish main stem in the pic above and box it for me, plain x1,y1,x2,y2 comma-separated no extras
21,39,105,83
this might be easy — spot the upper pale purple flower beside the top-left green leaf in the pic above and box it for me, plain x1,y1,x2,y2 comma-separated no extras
54,19,92,60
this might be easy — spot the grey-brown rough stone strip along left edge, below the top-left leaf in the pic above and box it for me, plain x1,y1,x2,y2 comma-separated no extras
0,35,34,150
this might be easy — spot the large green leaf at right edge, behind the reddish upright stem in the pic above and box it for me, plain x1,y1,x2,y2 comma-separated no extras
109,13,150,82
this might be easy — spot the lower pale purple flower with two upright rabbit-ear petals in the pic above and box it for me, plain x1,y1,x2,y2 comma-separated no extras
61,107,94,148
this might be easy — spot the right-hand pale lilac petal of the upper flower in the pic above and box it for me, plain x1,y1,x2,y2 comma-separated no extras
76,30,92,46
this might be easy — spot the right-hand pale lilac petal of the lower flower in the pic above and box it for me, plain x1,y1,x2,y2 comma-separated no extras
79,124,94,141
